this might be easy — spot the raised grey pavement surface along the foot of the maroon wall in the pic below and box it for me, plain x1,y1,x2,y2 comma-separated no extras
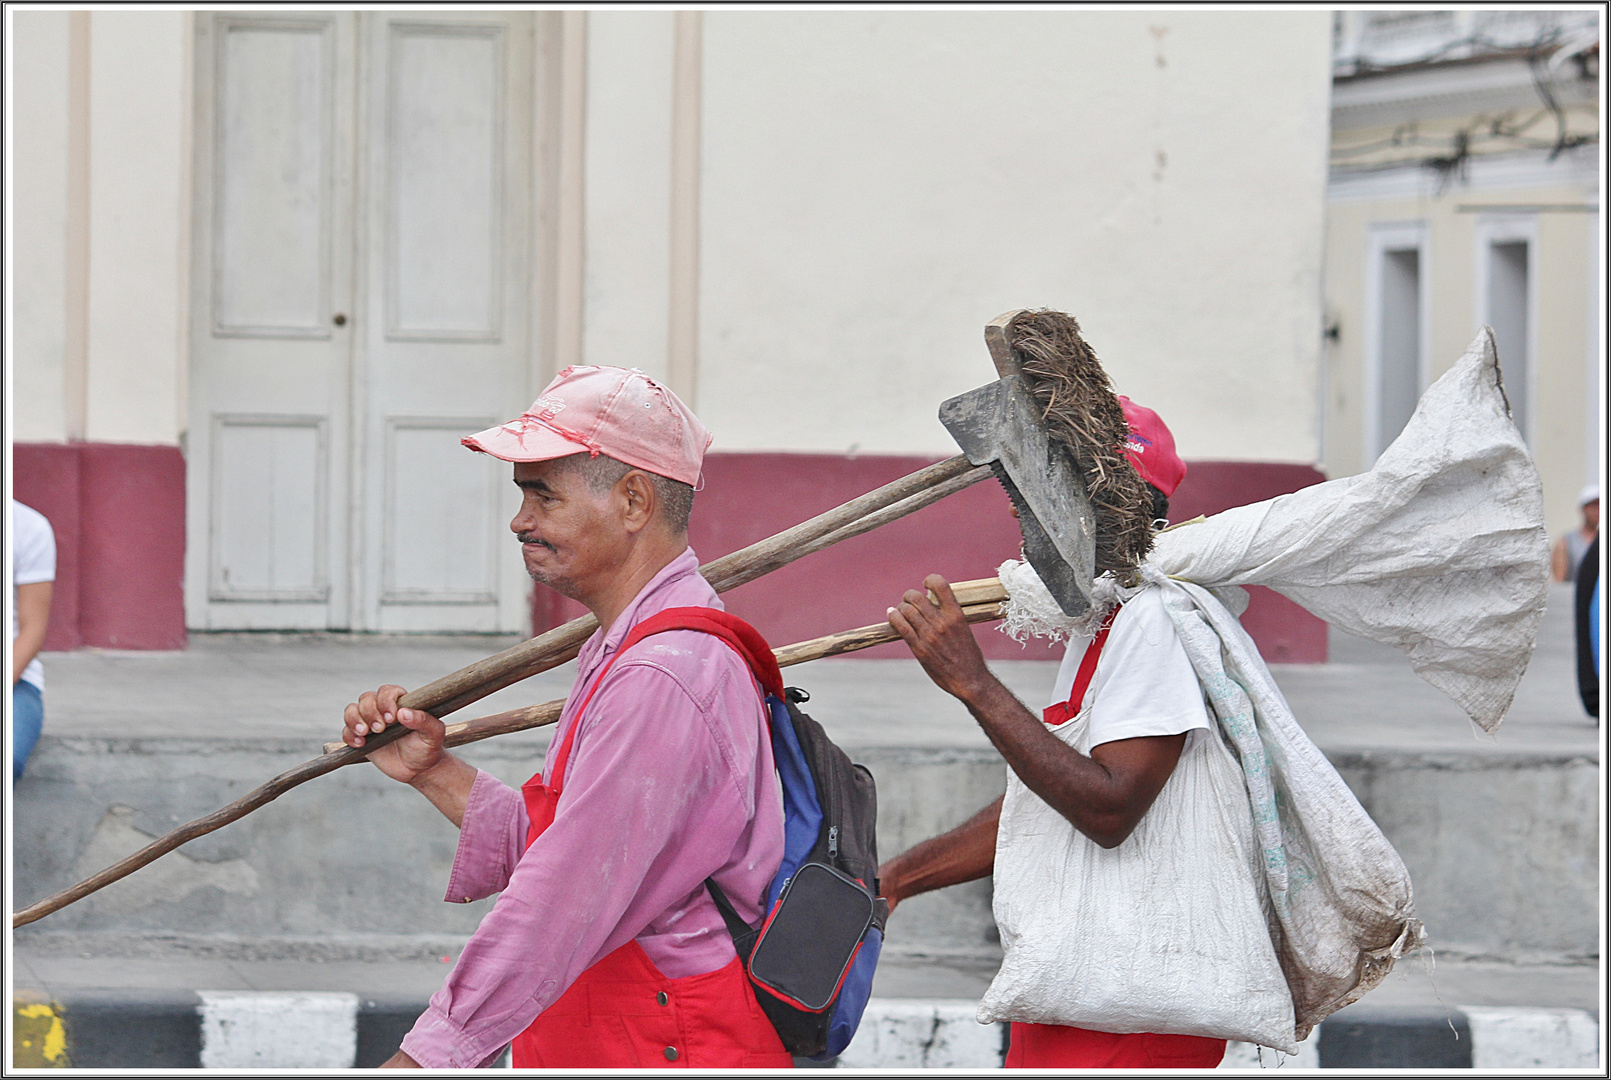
31,587,1600,758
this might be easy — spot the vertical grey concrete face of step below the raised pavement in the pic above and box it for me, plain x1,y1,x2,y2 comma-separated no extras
13,728,1600,962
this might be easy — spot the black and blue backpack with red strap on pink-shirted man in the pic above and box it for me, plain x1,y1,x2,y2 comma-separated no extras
617,608,889,1061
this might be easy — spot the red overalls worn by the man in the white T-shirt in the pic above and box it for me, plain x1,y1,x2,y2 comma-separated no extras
1004,608,1224,1069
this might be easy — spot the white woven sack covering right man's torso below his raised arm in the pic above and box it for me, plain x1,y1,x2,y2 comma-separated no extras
978,686,1297,1053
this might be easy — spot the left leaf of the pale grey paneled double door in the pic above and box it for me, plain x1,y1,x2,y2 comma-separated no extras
185,13,356,630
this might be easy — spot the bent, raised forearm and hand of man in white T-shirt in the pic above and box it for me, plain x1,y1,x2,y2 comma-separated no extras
889,574,1186,848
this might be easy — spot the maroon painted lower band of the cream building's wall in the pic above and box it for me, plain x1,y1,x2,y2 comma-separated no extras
11,443,1326,664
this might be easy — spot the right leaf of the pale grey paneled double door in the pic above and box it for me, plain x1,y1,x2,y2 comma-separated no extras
354,11,535,630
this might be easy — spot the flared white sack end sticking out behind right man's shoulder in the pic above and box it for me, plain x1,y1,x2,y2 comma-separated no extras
1150,327,1550,732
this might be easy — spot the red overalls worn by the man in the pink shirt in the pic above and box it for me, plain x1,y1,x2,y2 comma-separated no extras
512,621,794,1069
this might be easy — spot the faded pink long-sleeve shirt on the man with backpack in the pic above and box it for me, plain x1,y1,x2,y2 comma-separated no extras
403,548,783,1069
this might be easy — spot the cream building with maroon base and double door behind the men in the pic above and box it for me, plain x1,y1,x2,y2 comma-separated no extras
8,10,1595,659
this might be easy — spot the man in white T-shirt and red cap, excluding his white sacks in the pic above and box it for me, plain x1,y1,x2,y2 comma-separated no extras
880,397,1226,1069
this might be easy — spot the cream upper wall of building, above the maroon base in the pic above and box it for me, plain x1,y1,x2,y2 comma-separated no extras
13,10,1329,461
